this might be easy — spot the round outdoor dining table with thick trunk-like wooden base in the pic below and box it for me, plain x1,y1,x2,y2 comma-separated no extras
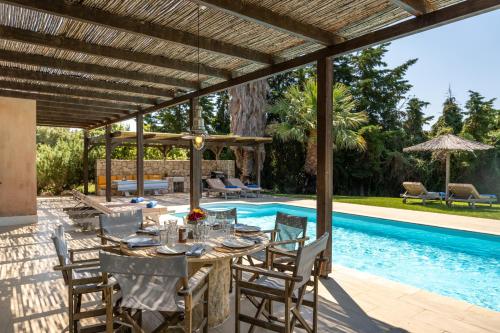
120,230,269,327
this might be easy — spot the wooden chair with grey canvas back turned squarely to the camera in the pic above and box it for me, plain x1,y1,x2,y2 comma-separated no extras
99,251,212,333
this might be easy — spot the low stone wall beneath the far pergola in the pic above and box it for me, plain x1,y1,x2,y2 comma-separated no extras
96,160,235,192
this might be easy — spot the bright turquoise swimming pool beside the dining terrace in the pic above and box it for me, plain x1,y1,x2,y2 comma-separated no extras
178,200,500,311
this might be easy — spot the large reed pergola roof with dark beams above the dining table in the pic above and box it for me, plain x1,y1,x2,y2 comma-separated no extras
0,0,500,129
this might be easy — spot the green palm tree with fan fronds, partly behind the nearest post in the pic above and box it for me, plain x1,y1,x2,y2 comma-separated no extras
267,78,368,176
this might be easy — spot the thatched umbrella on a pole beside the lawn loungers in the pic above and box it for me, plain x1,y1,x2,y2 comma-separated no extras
403,134,494,199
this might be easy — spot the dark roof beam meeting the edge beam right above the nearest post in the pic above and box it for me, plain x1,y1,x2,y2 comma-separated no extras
190,0,344,45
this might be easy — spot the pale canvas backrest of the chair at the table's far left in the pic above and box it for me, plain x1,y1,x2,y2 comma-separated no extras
98,209,143,244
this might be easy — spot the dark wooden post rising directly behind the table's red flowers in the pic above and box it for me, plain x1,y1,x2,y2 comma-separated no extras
189,98,202,209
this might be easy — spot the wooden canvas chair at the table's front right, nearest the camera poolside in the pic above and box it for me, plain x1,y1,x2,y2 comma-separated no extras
233,233,329,333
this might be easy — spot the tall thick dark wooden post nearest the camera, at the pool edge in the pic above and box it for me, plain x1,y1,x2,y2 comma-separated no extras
316,57,333,276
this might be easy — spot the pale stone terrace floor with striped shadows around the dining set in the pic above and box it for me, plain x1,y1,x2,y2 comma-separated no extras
0,196,500,333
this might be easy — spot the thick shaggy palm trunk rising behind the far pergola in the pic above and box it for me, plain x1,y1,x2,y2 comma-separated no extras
229,80,268,181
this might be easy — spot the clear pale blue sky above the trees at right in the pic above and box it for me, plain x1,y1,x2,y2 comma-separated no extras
385,10,500,121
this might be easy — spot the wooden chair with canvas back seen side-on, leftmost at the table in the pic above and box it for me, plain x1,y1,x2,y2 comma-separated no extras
52,225,117,333
